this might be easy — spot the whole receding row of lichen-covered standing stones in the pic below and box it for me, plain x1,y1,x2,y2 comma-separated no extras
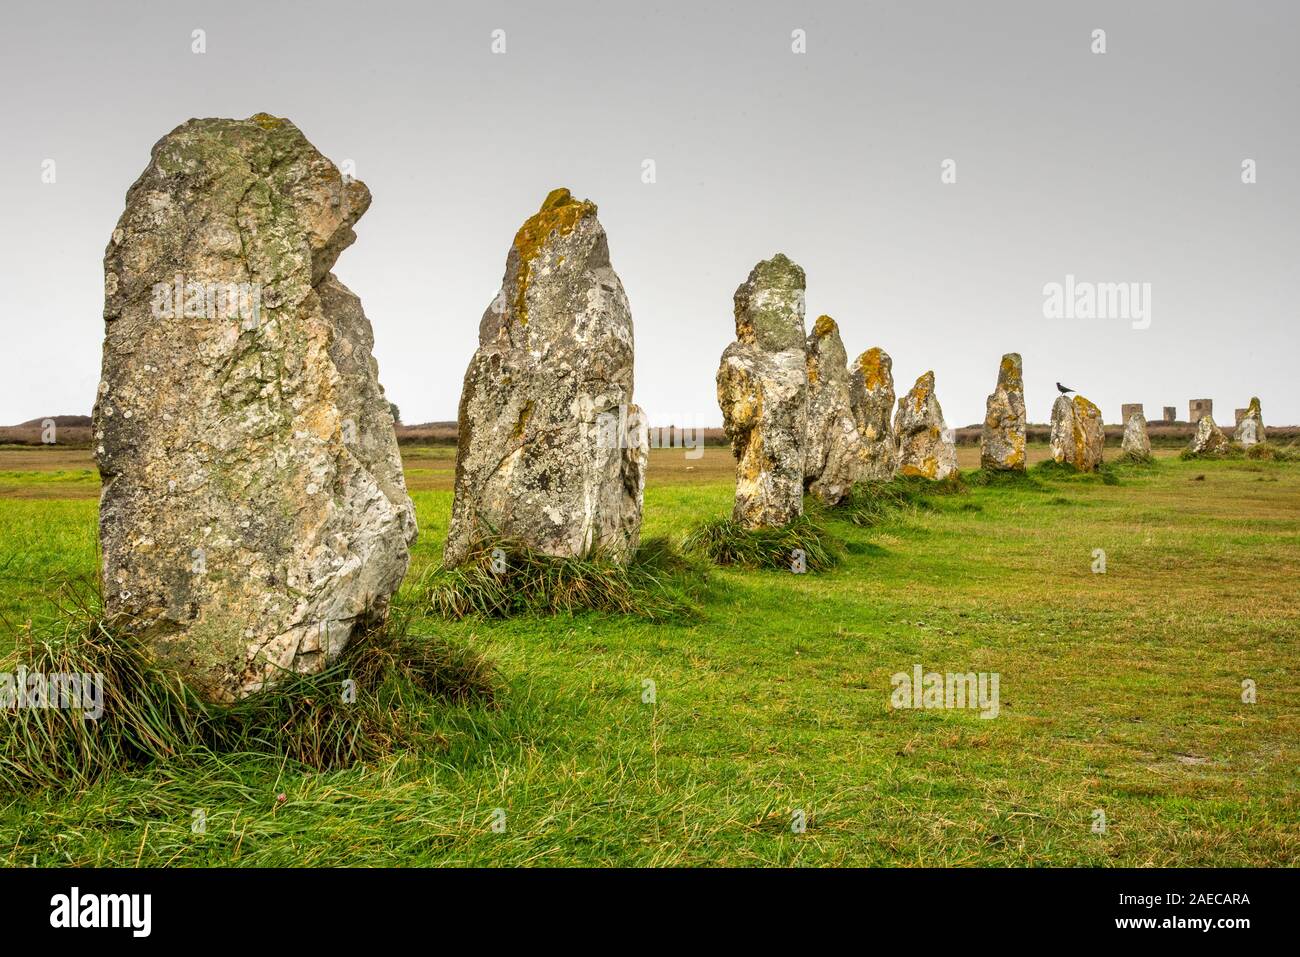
94,113,1264,702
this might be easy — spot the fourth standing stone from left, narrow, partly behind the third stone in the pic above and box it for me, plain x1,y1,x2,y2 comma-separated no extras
803,316,862,505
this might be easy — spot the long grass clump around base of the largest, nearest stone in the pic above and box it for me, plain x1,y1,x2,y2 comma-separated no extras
0,587,494,792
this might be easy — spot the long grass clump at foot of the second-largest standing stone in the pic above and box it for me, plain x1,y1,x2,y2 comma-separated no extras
410,540,706,622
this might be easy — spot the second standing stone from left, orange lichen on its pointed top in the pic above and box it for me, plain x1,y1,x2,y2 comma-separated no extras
443,189,649,566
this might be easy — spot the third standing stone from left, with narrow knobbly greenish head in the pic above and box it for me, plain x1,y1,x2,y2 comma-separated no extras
718,254,809,528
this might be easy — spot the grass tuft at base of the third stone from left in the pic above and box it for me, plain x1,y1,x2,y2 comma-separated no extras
683,515,844,572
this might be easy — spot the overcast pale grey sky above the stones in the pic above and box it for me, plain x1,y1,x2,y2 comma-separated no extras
0,0,1300,425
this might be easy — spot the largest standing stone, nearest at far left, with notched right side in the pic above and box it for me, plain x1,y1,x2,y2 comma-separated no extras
95,113,416,701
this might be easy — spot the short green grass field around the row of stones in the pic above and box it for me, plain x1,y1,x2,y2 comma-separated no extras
0,449,1300,866
